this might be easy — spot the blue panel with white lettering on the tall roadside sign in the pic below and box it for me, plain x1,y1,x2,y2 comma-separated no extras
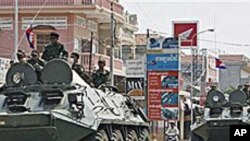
147,54,179,71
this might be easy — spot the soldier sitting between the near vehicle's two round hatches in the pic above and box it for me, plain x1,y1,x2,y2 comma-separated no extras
27,50,44,80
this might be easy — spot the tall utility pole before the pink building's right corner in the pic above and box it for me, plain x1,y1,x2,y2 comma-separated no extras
109,1,115,86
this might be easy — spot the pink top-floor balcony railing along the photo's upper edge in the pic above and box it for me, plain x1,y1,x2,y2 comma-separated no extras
0,0,123,15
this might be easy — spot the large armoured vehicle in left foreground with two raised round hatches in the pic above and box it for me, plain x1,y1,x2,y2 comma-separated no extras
0,59,150,141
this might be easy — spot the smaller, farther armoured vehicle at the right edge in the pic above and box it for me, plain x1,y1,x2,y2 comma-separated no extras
191,90,250,141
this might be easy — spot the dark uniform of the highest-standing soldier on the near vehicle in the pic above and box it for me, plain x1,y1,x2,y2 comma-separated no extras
42,43,67,61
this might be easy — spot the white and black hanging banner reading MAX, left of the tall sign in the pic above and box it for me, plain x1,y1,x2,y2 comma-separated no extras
125,59,145,100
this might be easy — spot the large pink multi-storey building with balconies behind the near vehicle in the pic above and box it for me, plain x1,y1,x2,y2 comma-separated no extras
0,0,138,92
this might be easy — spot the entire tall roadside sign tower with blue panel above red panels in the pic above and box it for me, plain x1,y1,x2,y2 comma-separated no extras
146,38,180,120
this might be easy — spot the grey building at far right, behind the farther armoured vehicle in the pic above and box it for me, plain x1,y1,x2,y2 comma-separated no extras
219,55,250,91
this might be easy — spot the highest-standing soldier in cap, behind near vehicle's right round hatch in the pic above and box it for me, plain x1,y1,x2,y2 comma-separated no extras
42,32,68,61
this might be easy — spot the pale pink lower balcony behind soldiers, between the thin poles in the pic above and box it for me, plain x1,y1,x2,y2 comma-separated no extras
81,53,125,76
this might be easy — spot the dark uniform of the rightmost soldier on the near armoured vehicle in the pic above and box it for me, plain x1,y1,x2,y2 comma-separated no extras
92,69,109,88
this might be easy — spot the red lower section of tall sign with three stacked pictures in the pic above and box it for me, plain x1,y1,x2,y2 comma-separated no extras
148,71,179,120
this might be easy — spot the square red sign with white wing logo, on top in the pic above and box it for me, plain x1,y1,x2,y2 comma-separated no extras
173,22,198,47
